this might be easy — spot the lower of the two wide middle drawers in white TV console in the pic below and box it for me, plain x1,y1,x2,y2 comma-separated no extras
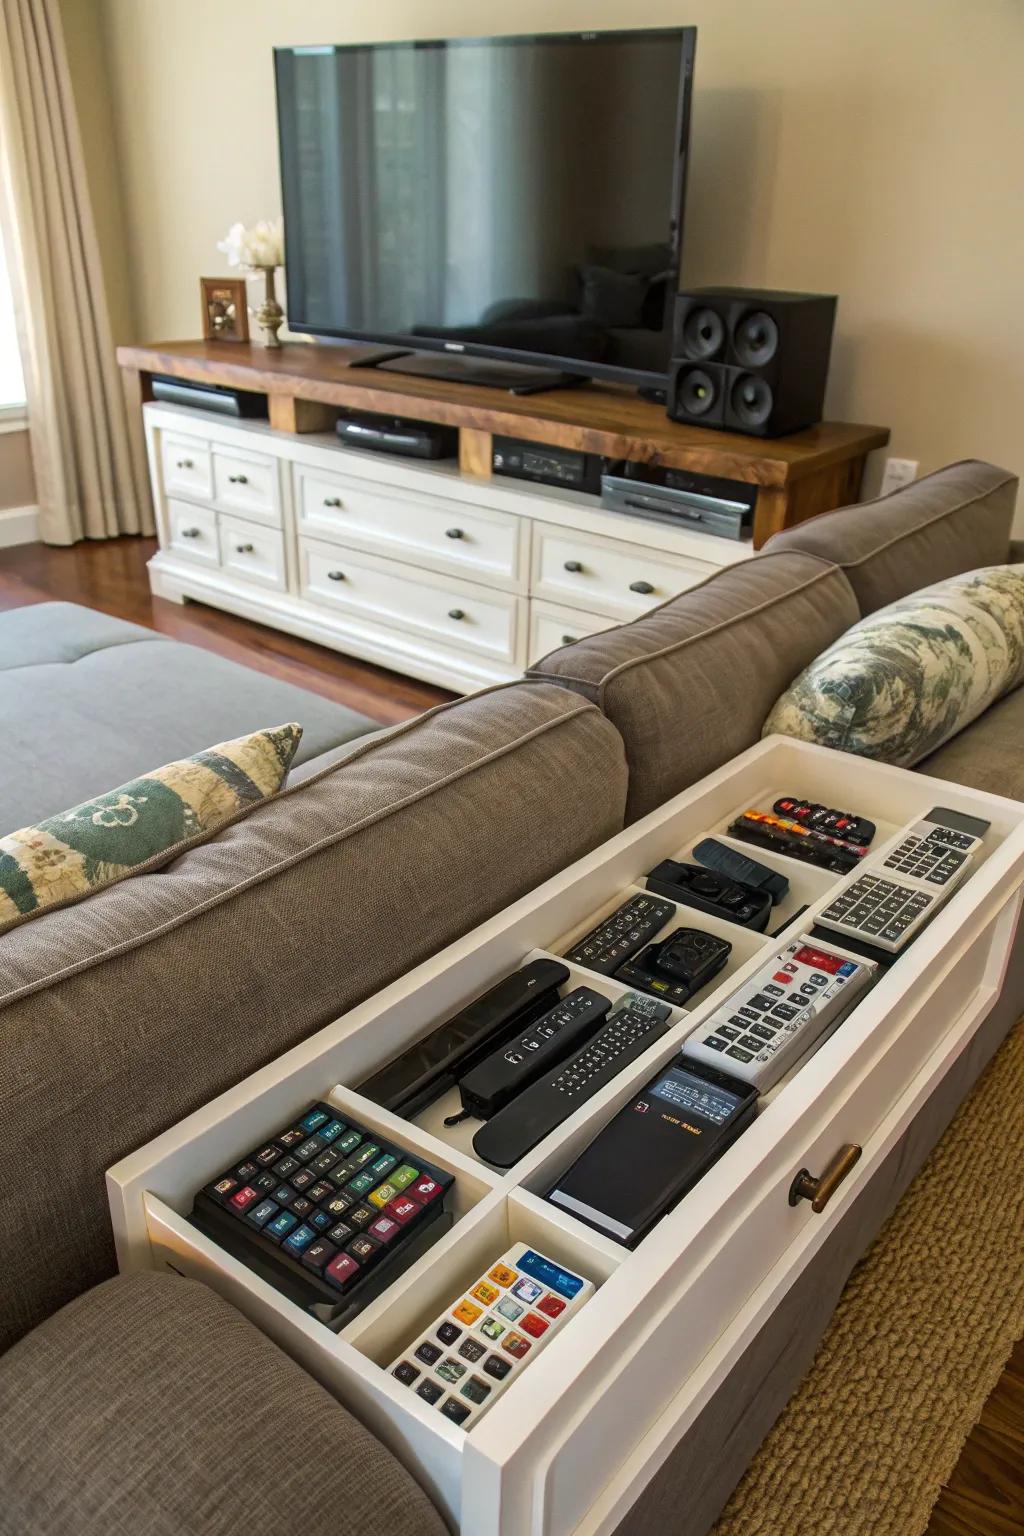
299,539,525,664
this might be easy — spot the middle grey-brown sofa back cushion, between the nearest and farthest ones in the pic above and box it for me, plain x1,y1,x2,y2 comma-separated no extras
528,554,860,822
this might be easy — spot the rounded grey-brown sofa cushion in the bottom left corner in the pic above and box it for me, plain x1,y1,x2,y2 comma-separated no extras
0,1273,445,1536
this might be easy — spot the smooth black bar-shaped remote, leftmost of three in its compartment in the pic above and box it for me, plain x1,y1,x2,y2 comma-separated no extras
358,960,570,1120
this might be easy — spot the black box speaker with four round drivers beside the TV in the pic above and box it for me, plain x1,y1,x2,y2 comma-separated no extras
666,289,837,438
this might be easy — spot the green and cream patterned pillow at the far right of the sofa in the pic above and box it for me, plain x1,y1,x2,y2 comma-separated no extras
761,565,1024,768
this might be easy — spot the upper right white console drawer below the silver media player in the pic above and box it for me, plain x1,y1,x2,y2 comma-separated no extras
531,522,717,619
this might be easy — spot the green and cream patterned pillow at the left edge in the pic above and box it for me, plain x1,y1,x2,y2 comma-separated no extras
0,725,302,934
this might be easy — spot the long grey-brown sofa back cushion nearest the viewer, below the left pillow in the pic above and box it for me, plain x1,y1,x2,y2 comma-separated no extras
0,684,626,1349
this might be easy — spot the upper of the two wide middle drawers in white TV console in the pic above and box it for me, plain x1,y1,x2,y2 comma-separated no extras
296,465,527,585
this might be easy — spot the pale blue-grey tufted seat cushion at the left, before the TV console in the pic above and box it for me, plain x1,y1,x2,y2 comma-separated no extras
0,602,375,836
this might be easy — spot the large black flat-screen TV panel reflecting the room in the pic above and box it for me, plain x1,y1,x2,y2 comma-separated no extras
276,28,695,382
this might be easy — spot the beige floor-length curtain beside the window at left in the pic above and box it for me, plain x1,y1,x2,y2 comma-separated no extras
0,0,154,544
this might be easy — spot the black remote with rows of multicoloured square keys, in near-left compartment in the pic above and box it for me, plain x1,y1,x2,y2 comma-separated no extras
192,1103,454,1324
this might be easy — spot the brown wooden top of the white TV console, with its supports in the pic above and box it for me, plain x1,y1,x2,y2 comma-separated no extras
118,341,889,548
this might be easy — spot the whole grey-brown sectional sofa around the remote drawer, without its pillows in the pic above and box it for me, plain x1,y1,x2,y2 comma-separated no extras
0,462,1024,1536
